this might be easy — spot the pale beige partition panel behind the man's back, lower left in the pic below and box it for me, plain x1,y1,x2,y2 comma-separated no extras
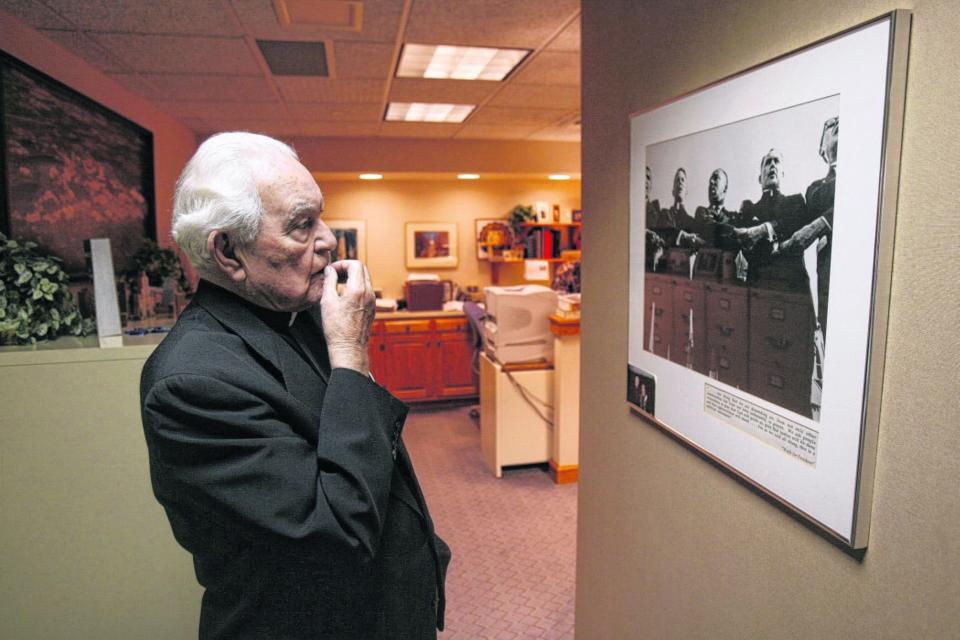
0,339,201,640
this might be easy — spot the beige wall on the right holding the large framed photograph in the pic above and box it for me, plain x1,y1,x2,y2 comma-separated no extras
577,0,960,640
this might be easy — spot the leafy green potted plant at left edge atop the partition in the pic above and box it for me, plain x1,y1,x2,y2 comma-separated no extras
0,233,94,344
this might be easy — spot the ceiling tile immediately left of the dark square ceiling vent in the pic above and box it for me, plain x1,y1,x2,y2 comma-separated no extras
94,33,262,75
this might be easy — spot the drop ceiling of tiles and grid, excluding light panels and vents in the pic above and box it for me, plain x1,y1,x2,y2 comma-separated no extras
0,0,580,140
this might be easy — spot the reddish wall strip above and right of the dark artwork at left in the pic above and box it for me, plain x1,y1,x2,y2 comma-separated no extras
0,11,197,250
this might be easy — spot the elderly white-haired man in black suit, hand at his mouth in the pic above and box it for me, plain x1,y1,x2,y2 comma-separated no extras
141,133,450,640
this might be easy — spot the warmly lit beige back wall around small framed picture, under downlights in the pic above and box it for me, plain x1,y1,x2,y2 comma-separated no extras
320,179,580,298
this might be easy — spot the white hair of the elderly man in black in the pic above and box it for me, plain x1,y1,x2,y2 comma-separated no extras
172,131,298,274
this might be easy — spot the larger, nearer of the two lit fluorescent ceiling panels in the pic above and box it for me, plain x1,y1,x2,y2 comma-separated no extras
397,44,530,80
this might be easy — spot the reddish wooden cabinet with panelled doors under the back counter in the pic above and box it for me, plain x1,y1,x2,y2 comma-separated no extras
369,316,478,402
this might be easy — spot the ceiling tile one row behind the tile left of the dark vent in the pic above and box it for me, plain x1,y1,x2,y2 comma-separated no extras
119,73,277,102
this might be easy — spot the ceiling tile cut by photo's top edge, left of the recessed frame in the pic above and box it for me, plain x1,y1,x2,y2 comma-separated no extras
44,0,241,36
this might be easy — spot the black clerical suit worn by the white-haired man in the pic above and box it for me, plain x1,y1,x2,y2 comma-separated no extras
141,281,450,640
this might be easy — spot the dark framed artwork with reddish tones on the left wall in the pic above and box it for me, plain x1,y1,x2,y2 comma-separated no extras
0,52,156,278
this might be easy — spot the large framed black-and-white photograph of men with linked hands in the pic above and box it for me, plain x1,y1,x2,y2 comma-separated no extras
627,11,910,548
